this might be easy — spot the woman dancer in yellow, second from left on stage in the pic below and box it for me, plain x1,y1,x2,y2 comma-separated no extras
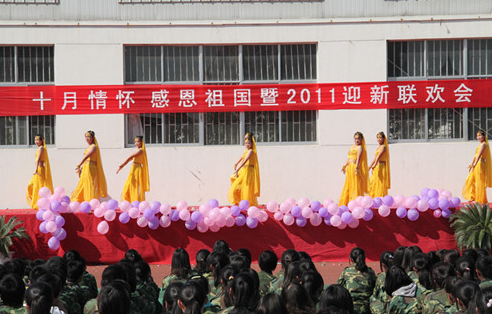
70,131,108,202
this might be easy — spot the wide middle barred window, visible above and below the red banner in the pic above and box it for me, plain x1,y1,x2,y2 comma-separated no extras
125,44,317,145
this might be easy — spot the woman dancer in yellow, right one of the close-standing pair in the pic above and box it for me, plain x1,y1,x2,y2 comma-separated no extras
369,132,391,198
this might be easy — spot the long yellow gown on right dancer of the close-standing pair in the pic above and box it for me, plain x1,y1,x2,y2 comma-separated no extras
369,139,391,198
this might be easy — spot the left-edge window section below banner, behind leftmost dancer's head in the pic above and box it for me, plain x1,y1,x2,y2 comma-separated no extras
0,116,55,146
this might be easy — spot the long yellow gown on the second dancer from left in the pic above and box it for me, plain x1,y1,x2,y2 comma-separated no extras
70,137,108,202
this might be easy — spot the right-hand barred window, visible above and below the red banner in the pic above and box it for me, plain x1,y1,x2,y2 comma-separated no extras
387,39,492,141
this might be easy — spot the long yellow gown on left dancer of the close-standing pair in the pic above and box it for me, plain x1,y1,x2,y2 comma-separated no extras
338,140,369,205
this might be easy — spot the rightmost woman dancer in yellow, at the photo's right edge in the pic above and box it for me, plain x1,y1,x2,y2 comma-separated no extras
462,130,492,204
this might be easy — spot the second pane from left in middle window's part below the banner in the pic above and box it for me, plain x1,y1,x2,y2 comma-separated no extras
164,113,200,144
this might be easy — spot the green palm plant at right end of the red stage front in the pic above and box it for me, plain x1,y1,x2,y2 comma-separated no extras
450,204,492,250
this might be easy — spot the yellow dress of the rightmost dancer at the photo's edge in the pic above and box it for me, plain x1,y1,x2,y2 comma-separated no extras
462,142,492,204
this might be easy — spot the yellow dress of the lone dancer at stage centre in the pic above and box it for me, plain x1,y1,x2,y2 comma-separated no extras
227,148,260,206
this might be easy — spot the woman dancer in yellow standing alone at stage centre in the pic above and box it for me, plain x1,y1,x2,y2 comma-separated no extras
227,133,260,206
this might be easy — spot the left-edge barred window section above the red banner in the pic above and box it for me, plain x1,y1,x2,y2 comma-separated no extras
0,46,55,84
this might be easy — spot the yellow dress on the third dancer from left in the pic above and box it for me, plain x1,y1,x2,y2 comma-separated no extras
121,144,149,203
